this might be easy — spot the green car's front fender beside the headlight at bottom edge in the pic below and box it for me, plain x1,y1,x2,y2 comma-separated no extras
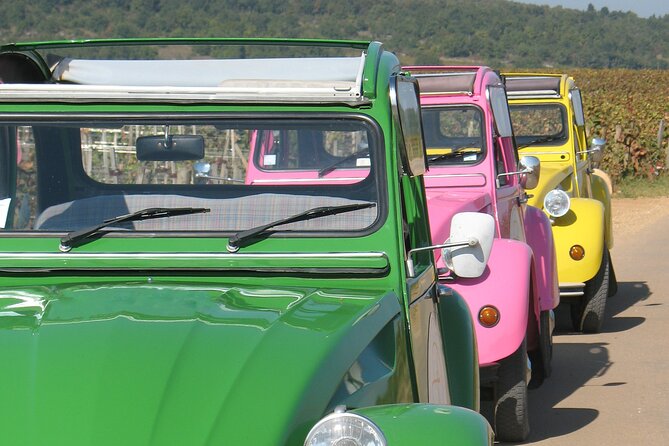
352,404,493,446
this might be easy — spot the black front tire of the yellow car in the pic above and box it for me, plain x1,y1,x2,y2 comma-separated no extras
571,249,610,333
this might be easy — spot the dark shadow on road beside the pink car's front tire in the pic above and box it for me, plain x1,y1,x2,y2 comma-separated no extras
522,342,612,444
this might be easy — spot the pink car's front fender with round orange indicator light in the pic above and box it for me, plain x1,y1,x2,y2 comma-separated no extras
444,239,532,366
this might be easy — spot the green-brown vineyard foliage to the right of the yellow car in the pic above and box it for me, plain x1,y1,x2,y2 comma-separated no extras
568,69,669,186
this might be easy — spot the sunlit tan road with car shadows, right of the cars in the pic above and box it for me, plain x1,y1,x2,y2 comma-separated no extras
524,198,669,446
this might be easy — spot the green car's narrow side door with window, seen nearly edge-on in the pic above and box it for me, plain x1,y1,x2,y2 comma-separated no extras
391,77,451,404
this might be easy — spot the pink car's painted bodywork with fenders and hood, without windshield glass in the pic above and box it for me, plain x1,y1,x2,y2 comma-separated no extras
404,67,559,366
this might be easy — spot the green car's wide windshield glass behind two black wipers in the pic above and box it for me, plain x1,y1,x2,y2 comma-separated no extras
0,118,384,235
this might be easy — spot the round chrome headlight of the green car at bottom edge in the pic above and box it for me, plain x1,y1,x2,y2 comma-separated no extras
304,412,386,446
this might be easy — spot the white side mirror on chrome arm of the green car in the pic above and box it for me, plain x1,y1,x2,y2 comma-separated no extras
442,212,495,278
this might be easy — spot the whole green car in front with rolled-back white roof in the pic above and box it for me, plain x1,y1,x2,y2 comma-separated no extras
0,39,492,446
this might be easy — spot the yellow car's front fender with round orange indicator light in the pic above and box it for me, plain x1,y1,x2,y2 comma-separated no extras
553,198,605,283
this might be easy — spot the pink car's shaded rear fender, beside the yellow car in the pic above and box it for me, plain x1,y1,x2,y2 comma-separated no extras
525,206,560,311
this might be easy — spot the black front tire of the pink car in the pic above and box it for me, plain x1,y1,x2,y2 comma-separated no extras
493,341,530,442
